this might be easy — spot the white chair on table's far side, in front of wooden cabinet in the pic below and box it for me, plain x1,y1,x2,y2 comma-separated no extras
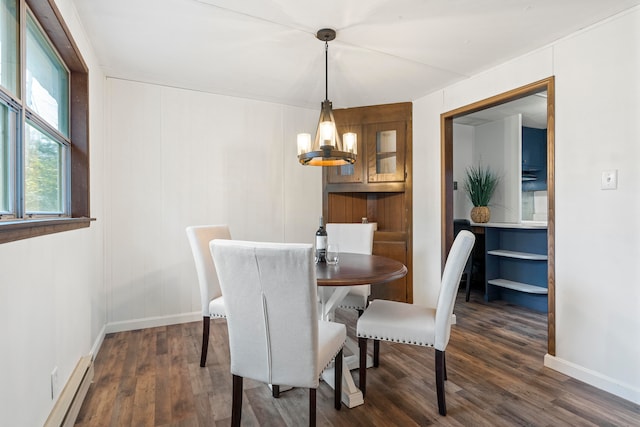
327,223,375,314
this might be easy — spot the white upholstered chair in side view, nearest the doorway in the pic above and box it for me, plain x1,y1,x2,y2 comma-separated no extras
357,230,475,415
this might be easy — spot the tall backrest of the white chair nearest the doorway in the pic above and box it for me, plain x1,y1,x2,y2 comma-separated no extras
434,230,476,351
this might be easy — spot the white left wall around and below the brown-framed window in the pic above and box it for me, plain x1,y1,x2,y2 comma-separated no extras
0,0,106,426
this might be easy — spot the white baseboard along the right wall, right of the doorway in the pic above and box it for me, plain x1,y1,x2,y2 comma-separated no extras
544,354,640,404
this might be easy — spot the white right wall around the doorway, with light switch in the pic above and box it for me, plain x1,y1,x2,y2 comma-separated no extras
413,8,640,403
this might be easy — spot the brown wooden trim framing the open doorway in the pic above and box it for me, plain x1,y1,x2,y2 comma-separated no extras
440,76,556,356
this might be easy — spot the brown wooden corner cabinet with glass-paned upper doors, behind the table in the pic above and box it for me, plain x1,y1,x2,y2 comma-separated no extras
323,103,413,302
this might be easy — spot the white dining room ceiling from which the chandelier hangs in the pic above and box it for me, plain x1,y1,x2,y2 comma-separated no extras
74,0,640,109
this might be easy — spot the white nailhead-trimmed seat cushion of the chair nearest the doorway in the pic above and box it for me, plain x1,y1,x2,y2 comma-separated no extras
357,300,436,347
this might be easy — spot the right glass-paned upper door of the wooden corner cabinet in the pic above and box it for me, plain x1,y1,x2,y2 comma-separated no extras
365,121,407,182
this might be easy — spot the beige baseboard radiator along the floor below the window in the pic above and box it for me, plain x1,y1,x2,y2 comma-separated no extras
44,356,93,427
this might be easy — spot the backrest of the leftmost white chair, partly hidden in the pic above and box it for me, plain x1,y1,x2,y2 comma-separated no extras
187,225,231,317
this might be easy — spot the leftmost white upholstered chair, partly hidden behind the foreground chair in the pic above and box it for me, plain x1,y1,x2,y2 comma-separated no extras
187,225,231,367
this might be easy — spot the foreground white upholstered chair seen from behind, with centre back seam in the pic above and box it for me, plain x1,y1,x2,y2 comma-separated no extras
210,240,347,426
